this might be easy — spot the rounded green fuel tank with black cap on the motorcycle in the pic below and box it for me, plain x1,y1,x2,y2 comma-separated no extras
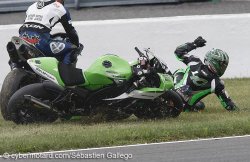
82,54,132,90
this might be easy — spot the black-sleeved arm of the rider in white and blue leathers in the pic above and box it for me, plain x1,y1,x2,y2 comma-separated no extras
60,9,79,47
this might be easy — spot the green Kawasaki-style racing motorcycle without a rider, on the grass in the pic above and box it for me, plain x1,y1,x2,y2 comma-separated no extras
8,48,183,124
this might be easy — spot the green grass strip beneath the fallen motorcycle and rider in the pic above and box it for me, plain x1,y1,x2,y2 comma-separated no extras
0,79,250,154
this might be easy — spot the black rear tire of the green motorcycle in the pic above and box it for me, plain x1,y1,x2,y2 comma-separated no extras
7,83,58,124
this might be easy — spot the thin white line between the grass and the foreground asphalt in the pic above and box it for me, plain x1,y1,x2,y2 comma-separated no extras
0,135,250,158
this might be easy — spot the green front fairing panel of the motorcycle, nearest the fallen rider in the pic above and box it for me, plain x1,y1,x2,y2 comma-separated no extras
140,73,174,93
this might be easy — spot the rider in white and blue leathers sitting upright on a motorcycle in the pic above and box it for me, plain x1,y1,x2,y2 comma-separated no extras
16,0,83,64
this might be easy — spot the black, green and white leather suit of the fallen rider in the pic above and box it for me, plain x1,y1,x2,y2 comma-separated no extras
174,43,237,111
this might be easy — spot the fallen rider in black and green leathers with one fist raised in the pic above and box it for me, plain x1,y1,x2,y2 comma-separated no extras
174,37,239,111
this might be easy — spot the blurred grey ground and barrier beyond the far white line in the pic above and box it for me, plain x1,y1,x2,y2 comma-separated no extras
0,0,250,25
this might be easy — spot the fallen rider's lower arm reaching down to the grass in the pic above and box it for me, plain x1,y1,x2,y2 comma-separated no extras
215,80,239,111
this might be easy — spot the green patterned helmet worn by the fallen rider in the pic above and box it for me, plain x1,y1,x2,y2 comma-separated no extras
204,49,229,77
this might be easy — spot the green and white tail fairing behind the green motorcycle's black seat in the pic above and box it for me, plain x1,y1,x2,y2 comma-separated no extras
28,57,65,86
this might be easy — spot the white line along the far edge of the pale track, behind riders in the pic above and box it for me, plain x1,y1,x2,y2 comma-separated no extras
0,13,250,30
